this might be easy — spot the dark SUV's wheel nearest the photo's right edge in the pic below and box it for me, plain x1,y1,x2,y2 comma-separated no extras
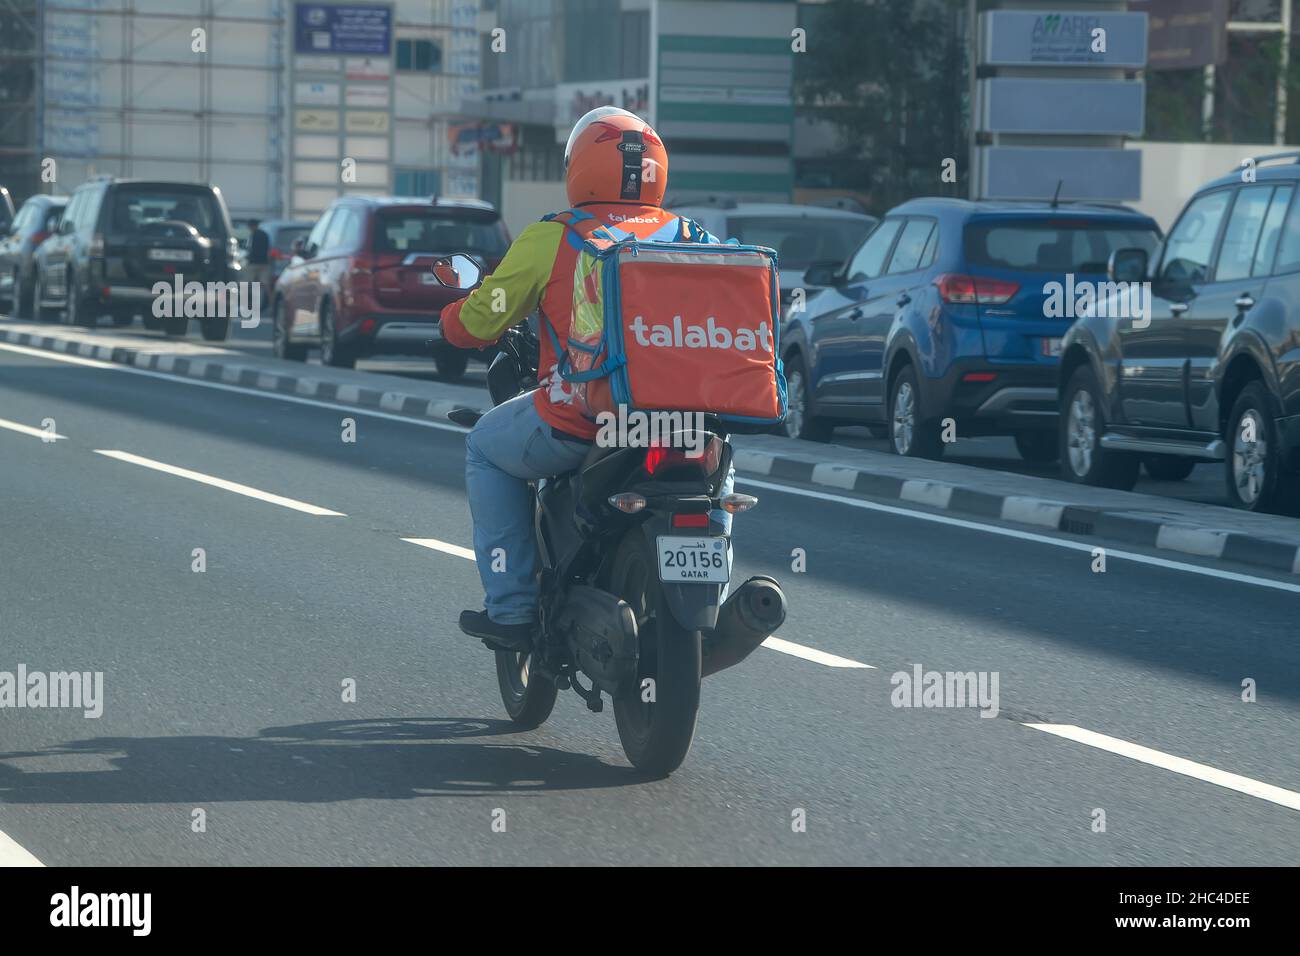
1223,381,1296,514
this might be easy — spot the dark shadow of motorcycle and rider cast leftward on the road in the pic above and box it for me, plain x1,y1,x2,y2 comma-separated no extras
0,718,645,805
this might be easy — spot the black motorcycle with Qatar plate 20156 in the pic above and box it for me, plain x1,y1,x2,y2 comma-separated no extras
433,255,785,775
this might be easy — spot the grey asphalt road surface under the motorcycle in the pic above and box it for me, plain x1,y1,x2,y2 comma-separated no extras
0,346,1300,865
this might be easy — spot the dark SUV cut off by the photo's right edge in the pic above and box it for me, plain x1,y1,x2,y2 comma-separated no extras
1060,152,1300,512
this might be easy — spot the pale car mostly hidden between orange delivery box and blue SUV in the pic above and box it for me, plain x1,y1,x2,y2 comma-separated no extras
670,199,880,306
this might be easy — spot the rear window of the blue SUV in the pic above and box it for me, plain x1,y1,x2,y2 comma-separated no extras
962,216,1160,276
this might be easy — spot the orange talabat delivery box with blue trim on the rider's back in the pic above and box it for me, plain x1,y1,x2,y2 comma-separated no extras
546,209,785,424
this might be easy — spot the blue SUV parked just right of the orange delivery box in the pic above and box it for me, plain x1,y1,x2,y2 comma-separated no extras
781,199,1160,462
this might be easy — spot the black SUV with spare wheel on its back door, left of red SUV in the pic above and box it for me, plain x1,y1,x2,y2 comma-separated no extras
33,178,242,341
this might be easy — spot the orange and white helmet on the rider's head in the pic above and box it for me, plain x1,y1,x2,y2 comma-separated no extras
564,107,668,206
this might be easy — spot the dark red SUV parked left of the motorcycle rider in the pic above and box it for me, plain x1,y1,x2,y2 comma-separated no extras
270,196,510,380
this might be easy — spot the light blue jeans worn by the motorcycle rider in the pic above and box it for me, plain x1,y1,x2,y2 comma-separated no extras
465,392,736,624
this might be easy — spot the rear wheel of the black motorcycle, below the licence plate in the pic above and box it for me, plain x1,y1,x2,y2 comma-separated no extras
608,528,702,777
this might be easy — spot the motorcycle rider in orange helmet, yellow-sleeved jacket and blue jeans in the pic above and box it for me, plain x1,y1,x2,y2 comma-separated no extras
441,107,718,652
